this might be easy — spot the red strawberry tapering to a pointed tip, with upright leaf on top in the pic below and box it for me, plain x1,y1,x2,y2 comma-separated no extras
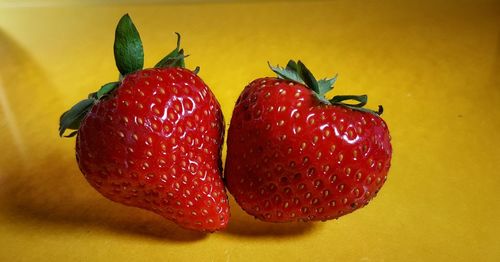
60,15,229,232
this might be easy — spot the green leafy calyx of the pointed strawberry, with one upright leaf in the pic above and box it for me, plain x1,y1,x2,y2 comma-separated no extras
59,14,190,137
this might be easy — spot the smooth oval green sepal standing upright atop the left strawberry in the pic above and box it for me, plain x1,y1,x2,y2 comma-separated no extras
113,14,144,76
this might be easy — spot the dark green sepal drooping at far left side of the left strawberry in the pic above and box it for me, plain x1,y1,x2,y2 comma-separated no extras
59,98,96,137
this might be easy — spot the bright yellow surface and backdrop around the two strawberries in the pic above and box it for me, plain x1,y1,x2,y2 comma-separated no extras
0,0,500,261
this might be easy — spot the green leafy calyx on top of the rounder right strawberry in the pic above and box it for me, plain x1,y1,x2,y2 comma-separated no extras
268,60,384,115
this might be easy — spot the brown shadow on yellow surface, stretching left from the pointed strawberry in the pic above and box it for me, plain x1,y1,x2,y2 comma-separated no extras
1,153,206,241
